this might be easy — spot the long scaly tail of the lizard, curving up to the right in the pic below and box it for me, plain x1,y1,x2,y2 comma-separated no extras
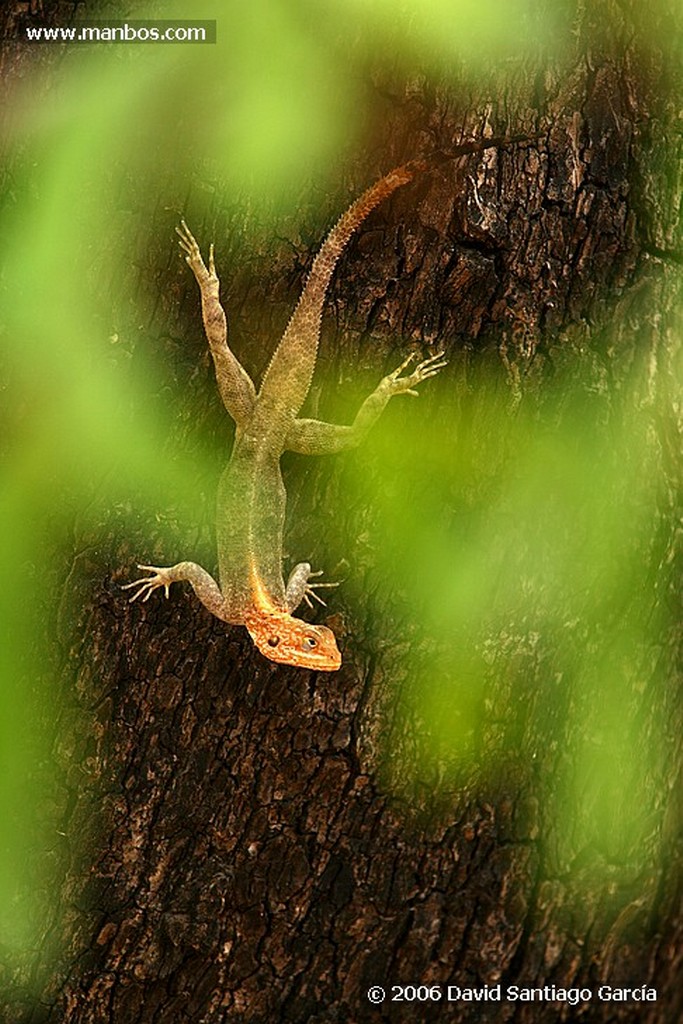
261,161,417,415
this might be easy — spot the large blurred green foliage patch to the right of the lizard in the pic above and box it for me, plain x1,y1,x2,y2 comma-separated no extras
346,362,676,870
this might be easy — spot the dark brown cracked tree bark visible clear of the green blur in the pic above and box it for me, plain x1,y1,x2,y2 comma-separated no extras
5,0,683,1024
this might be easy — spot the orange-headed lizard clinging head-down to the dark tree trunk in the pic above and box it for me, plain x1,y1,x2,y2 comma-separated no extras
124,161,445,672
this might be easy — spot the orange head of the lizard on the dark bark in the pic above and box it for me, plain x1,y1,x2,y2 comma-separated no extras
245,611,341,672
